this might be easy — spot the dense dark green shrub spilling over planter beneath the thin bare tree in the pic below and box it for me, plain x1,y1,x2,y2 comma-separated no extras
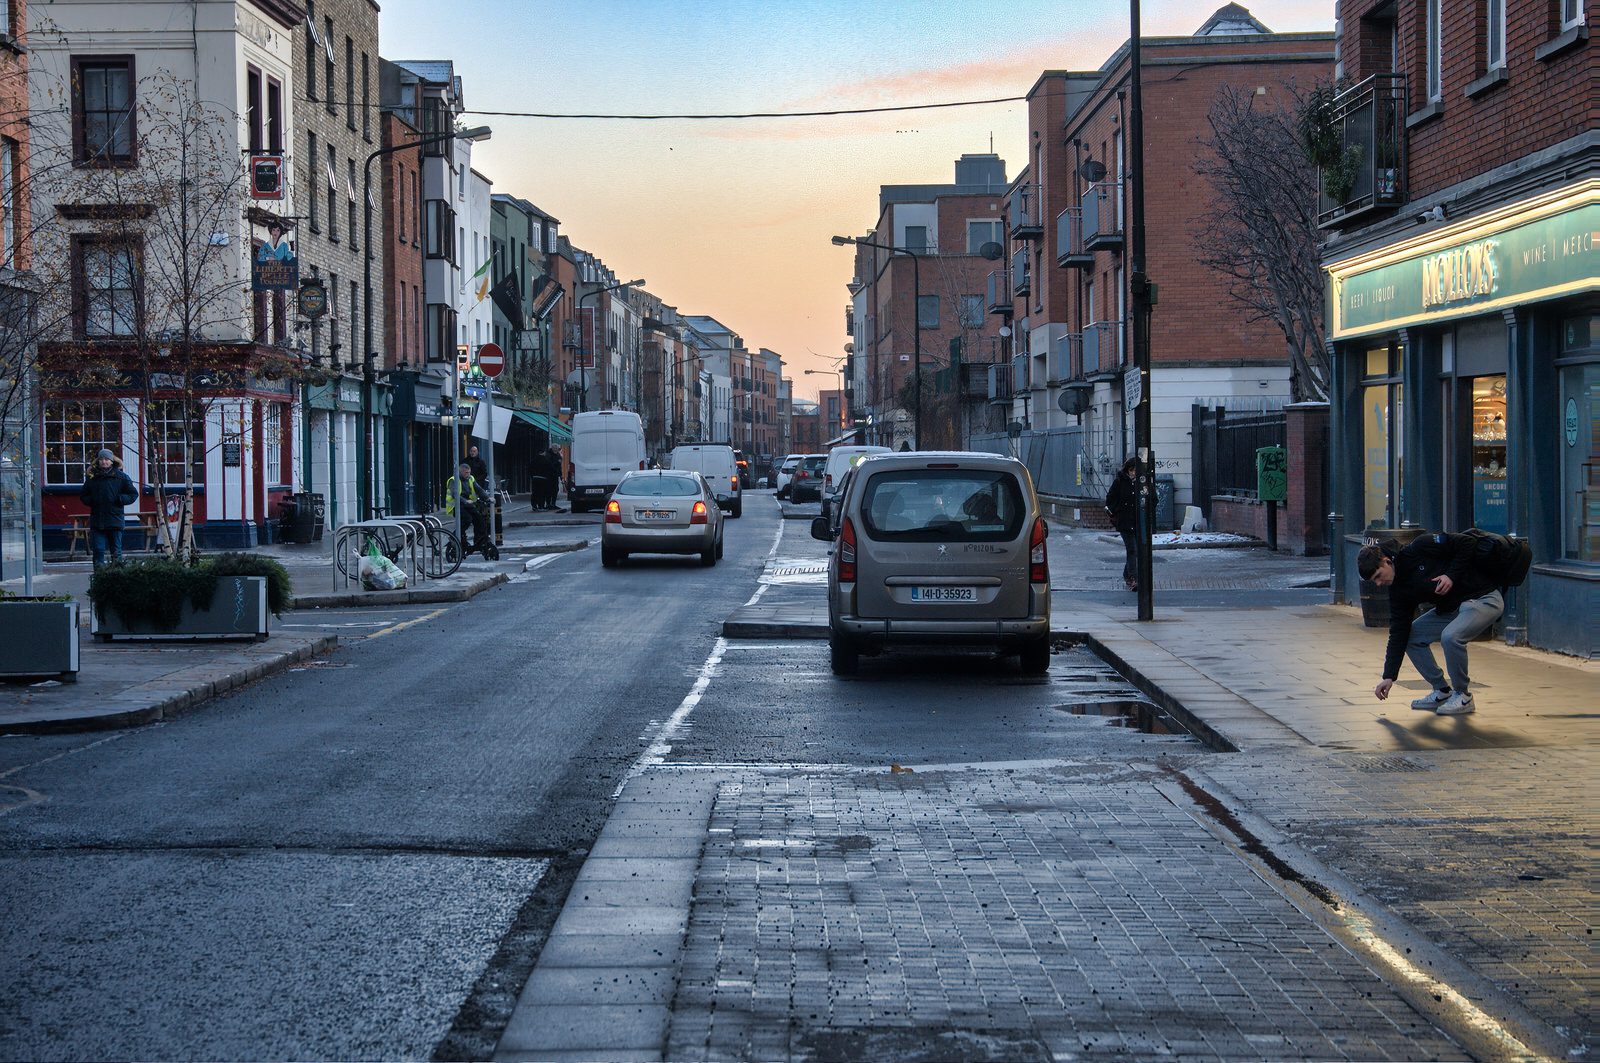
90,554,294,631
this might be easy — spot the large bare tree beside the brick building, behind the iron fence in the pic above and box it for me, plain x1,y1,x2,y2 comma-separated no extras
1192,85,1328,402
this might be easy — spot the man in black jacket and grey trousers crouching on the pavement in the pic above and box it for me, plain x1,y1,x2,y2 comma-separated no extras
1355,532,1506,716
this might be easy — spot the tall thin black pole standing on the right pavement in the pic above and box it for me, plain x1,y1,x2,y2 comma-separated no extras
1122,0,1155,620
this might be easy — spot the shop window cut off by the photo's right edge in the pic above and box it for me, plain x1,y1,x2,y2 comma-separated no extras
1560,317,1600,564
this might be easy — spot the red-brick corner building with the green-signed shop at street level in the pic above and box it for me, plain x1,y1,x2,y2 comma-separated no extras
1320,0,1600,656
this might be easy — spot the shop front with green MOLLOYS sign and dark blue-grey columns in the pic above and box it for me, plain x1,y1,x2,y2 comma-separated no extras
1328,181,1600,656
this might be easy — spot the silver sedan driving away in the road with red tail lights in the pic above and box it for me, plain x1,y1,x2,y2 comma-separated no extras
600,469,722,568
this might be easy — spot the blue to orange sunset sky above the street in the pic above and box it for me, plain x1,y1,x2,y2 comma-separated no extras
381,0,1333,397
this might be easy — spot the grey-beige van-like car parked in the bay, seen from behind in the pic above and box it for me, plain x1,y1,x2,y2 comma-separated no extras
811,451,1050,676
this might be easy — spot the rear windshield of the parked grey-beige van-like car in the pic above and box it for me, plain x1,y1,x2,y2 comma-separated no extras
861,469,1027,543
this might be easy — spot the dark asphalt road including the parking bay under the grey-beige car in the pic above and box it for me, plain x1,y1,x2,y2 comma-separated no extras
0,495,1260,1058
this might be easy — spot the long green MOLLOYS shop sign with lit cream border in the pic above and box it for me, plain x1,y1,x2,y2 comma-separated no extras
1328,181,1600,339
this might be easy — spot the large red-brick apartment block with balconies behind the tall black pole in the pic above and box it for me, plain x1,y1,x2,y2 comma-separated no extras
989,3,1333,503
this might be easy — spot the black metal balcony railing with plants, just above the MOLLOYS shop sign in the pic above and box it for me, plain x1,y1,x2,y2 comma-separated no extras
1317,74,1406,229
